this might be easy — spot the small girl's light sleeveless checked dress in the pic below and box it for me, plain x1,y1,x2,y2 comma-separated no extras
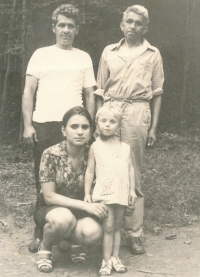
92,138,130,206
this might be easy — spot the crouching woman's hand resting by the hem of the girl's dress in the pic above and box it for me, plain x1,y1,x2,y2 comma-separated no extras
86,203,108,221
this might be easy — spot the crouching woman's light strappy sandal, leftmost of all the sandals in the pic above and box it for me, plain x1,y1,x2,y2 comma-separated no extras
36,250,52,273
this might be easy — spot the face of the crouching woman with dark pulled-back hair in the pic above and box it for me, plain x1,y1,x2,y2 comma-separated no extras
62,114,91,146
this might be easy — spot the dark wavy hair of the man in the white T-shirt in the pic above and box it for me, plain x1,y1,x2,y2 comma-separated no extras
52,4,79,25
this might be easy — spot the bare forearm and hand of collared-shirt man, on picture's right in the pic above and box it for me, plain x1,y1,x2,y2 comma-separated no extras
147,94,162,147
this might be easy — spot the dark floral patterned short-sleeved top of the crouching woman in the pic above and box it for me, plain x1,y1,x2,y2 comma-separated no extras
37,141,88,207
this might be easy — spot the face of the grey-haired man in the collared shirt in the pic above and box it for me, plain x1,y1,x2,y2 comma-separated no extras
120,12,148,42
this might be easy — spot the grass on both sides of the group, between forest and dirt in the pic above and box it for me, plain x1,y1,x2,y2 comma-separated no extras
0,133,200,232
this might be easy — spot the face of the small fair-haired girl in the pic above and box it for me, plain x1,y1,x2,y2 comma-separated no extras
97,112,120,137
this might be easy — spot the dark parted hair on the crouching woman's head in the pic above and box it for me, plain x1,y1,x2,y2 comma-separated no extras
62,106,92,128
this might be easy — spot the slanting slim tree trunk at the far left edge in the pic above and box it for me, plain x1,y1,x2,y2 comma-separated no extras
0,0,17,126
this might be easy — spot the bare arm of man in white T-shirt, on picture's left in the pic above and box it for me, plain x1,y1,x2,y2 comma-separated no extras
22,75,38,146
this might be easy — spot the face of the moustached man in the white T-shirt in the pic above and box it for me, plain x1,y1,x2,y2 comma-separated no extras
52,14,79,49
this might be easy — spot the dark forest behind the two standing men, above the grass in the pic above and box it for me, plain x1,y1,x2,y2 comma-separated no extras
0,0,200,143
